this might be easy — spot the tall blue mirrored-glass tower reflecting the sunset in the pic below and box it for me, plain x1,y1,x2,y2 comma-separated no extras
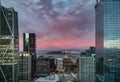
95,0,120,82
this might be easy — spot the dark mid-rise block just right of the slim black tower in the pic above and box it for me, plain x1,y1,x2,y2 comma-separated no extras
36,56,50,78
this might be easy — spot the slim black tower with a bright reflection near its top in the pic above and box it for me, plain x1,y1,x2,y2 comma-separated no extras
23,33,36,78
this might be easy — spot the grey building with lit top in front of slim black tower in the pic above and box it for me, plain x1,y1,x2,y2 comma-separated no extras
19,52,31,82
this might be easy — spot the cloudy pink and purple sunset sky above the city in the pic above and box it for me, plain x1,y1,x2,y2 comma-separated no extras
1,0,96,50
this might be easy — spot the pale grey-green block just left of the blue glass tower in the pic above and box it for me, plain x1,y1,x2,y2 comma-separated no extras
79,56,95,82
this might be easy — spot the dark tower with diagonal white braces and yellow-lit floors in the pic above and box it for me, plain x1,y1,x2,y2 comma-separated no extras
0,5,19,82
